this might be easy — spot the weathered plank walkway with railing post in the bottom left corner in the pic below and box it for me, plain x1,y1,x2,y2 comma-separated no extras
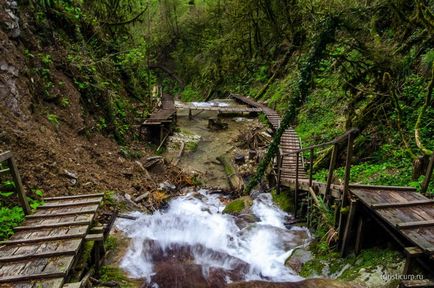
0,152,104,288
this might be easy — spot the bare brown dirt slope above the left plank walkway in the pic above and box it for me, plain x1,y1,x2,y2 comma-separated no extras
0,0,182,201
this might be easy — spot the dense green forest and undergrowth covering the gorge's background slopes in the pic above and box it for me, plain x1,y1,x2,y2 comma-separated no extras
7,0,434,186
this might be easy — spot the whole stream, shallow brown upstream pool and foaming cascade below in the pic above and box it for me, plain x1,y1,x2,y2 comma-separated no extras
116,99,311,288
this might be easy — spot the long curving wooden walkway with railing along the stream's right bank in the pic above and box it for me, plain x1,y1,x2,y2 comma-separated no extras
231,94,434,287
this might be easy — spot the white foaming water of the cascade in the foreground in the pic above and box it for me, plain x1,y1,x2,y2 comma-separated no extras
116,190,311,283
